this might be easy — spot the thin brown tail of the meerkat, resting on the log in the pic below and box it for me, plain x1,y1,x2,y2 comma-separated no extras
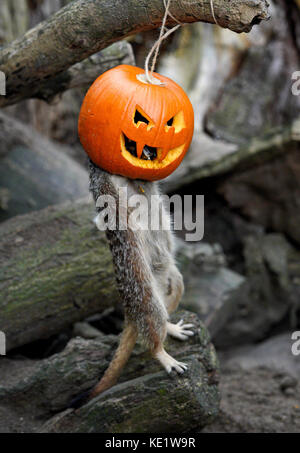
89,323,137,399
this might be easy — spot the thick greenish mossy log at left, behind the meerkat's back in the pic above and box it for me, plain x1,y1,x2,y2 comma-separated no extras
0,200,118,350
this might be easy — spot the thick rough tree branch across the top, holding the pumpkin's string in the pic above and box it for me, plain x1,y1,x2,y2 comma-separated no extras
0,0,269,107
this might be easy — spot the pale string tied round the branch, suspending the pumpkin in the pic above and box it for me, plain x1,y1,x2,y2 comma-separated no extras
145,0,220,83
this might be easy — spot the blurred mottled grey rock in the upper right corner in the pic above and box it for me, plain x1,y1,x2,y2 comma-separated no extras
206,0,300,143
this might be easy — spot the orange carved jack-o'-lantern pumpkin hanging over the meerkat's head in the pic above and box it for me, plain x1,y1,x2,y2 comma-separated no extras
78,65,194,181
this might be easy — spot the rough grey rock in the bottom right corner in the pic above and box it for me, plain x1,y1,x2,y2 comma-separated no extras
203,333,300,433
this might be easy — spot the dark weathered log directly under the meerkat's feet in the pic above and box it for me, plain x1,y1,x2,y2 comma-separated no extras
41,312,220,433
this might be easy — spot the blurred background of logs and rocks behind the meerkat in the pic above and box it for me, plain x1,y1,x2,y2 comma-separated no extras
0,0,300,432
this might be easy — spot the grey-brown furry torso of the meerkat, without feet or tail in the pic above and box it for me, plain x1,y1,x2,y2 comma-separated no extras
90,161,183,355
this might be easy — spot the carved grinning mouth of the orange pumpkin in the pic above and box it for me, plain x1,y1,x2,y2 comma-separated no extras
120,133,185,169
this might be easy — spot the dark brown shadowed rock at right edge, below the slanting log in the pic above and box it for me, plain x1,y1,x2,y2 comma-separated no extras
218,144,300,244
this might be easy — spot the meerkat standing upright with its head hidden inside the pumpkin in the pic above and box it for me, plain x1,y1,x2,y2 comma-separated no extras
89,161,194,399
